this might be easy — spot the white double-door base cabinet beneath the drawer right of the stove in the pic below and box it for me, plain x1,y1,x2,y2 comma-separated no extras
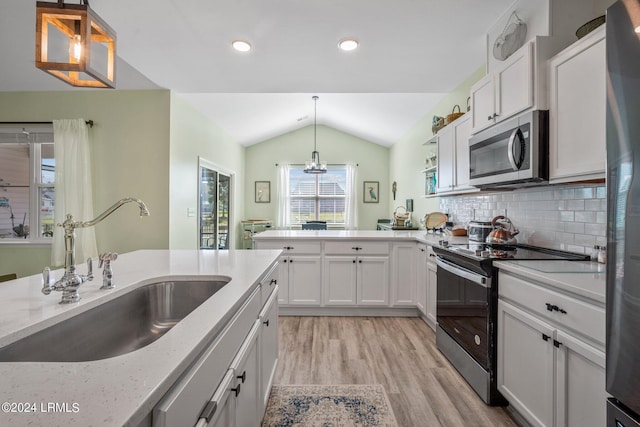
498,300,607,427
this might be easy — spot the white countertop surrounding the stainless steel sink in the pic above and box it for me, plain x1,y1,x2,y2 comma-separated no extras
0,250,280,427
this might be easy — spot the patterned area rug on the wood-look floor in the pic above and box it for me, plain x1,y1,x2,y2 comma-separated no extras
262,385,398,427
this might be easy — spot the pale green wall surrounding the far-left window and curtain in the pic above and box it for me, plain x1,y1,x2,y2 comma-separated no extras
0,90,169,277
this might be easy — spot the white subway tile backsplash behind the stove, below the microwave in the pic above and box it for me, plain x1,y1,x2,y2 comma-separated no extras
440,184,607,253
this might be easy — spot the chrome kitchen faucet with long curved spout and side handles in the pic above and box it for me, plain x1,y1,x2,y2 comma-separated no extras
42,197,149,304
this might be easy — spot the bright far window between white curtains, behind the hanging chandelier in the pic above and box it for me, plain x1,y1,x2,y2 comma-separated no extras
289,166,347,225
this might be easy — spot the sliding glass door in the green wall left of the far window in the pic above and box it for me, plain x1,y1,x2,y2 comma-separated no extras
198,159,233,249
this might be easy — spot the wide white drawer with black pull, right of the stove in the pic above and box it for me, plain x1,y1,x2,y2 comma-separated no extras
498,271,605,345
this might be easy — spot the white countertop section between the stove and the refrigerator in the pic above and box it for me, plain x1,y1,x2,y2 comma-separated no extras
493,261,606,304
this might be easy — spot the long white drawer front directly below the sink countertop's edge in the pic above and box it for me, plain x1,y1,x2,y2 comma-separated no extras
153,289,262,427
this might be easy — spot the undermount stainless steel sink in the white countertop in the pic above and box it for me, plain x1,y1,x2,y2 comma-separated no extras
0,279,230,362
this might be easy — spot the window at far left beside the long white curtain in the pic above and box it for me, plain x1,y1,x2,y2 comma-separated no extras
0,125,55,243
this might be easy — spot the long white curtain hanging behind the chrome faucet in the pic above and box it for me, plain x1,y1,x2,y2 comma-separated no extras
51,119,98,266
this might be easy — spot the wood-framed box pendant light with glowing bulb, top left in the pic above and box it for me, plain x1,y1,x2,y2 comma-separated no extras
36,0,116,88
